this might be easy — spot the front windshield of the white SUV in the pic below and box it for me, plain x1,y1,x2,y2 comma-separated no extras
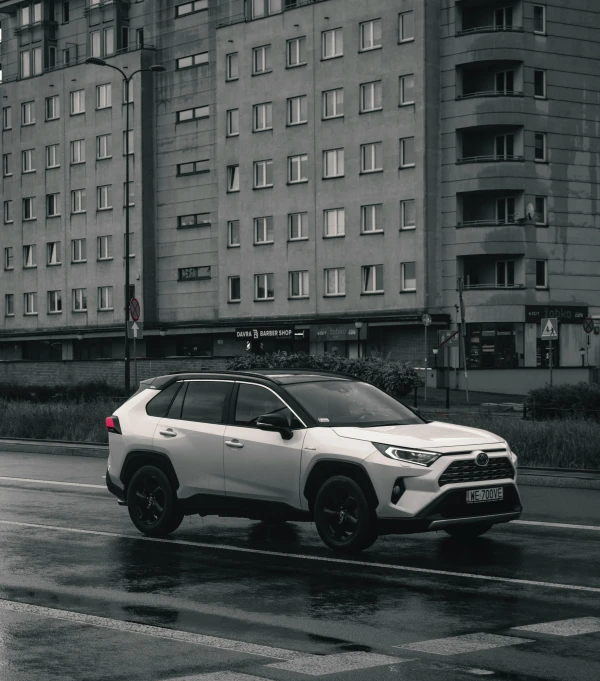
286,380,423,428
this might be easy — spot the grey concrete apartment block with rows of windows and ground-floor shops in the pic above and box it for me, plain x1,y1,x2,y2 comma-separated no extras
0,0,600,392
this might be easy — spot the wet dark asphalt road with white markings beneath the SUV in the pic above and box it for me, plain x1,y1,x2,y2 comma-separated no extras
0,453,600,681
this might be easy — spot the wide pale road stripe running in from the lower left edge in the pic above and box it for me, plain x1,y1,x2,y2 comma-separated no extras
0,599,307,660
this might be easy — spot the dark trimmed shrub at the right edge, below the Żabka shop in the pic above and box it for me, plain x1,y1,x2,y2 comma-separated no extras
525,383,600,420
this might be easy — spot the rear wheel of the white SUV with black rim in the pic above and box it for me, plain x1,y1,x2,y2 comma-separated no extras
127,466,183,537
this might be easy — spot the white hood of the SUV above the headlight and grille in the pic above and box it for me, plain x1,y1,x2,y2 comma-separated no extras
332,421,504,451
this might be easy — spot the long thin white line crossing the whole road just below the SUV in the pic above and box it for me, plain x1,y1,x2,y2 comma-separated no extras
0,520,600,594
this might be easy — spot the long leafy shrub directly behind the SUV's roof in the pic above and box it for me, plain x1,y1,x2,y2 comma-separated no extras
227,352,420,397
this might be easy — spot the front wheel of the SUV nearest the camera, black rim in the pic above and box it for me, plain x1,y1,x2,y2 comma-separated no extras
314,475,377,553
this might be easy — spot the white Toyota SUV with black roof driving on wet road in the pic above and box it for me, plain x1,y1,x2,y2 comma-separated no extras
106,370,522,552
